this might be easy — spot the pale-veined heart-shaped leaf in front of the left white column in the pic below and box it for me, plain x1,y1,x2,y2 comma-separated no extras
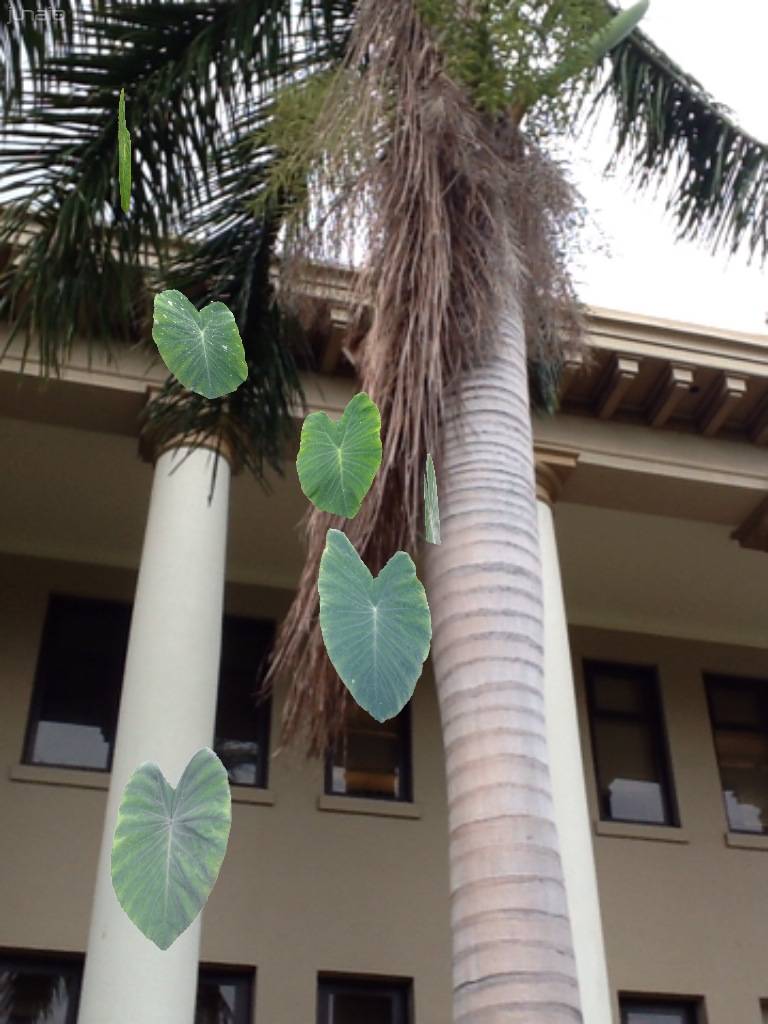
112,746,231,949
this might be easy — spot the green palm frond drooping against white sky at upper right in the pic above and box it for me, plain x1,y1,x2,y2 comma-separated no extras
596,25,768,261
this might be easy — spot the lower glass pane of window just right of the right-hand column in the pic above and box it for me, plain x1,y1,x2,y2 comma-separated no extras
594,719,669,824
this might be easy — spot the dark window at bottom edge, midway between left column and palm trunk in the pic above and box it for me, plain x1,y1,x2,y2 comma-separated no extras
317,978,411,1024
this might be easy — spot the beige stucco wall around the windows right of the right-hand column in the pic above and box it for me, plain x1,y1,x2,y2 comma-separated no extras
571,628,768,1024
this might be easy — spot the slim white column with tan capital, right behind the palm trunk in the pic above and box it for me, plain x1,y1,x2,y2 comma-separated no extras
537,449,614,1024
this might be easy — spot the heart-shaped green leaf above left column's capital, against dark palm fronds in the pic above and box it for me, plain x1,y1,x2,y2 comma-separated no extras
152,289,248,398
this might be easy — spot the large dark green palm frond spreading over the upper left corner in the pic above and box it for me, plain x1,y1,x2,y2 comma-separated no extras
0,0,351,369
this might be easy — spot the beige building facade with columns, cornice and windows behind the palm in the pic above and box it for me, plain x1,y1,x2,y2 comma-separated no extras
0,311,768,1024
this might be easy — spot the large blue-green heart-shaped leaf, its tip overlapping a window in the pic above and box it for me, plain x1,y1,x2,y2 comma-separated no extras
317,529,432,722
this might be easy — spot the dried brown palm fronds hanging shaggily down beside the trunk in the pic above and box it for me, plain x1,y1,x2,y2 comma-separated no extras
269,0,581,754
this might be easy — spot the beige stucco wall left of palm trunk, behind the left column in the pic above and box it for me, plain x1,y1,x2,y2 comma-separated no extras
0,556,451,1024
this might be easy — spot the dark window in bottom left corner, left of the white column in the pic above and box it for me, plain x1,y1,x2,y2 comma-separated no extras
0,957,82,1024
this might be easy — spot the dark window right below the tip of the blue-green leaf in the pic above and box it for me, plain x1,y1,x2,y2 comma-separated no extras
326,701,413,801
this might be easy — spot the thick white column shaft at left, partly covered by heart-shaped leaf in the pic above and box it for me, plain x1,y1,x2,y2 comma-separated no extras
78,447,230,1024
